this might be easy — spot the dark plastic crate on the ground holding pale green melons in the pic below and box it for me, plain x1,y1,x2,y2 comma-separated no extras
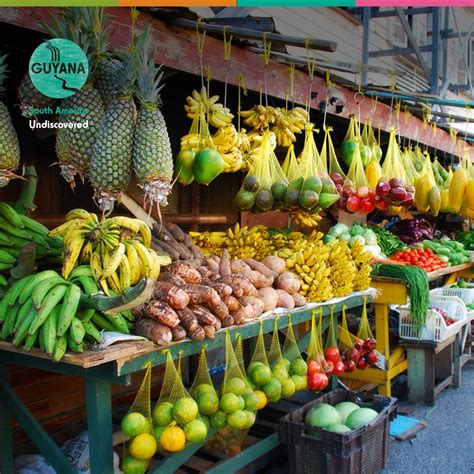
280,390,397,474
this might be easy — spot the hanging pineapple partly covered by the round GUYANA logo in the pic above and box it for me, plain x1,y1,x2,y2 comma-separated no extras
45,7,105,188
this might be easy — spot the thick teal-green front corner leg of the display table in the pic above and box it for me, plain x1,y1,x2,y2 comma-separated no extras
86,379,114,474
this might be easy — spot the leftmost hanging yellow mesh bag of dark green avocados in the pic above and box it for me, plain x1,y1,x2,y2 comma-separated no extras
235,132,288,212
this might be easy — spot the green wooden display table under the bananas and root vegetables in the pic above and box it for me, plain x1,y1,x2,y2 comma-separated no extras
0,292,371,474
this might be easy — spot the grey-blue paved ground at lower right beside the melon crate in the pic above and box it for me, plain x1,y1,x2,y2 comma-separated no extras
383,365,474,474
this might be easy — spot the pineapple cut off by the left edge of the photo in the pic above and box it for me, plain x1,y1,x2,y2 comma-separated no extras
0,55,20,187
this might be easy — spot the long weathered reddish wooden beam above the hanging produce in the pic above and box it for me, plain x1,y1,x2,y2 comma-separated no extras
0,8,468,159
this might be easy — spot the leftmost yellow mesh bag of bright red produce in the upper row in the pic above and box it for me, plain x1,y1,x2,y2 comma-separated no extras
337,142,375,214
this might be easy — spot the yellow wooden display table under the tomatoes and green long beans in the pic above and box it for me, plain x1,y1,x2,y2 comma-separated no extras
344,263,474,397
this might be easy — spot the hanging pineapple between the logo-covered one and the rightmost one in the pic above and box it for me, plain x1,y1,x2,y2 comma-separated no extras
89,52,137,212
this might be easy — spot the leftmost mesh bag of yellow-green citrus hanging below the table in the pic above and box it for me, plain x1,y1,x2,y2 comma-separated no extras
120,364,158,472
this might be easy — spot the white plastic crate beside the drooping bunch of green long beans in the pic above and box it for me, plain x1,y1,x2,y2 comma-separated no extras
398,292,467,342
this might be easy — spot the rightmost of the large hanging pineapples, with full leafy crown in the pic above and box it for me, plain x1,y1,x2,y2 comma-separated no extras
133,27,173,206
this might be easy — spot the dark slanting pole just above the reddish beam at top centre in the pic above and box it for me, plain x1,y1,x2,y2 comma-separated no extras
166,18,337,53
